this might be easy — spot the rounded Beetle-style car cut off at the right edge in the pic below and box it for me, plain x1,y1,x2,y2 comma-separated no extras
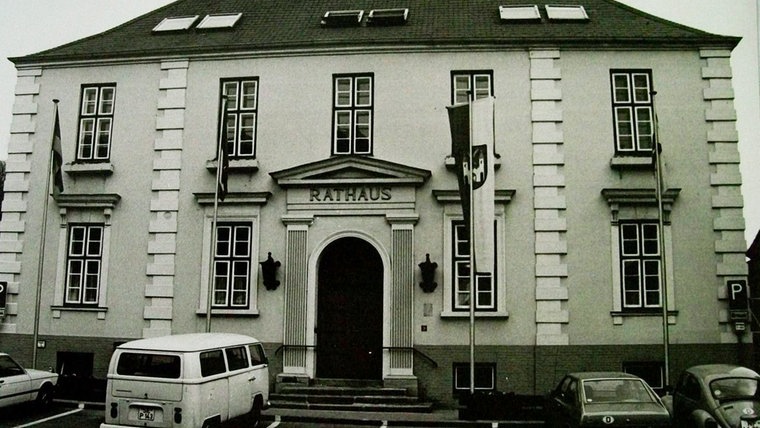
673,364,760,428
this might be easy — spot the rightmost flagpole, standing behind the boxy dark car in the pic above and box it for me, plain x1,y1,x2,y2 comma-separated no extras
651,91,670,386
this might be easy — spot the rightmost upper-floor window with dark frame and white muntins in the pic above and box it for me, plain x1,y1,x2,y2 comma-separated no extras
610,70,655,156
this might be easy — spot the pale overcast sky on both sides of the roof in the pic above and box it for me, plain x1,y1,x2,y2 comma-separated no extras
0,0,760,245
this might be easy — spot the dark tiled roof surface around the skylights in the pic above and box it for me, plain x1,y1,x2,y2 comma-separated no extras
11,0,740,64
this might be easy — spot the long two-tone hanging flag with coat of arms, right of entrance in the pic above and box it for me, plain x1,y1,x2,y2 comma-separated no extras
448,97,496,274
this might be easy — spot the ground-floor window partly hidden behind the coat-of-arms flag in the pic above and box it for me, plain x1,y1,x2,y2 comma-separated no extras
451,221,496,311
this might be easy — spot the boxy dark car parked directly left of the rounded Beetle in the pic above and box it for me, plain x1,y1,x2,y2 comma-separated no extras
545,372,670,428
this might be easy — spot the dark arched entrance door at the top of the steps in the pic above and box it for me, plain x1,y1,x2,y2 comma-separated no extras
316,237,383,379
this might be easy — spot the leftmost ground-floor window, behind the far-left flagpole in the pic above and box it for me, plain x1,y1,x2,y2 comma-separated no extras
65,225,103,306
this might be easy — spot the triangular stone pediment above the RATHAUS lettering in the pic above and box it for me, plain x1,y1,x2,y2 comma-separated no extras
270,156,430,187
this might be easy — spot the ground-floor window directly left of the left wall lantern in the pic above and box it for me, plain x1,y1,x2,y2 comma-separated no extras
213,223,252,309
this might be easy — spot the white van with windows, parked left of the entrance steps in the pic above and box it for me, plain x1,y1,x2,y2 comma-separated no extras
100,333,269,428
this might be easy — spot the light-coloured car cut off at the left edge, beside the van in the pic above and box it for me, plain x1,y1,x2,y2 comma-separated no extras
0,353,58,407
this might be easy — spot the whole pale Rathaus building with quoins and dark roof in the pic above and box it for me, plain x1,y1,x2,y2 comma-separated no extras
0,0,749,404
